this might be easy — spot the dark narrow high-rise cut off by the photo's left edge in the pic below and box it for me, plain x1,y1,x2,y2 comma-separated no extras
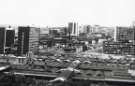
0,27,6,54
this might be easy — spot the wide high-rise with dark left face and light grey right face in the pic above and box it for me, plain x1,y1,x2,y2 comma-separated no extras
17,27,40,55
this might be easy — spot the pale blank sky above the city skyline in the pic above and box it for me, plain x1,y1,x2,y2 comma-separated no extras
0,0,135,26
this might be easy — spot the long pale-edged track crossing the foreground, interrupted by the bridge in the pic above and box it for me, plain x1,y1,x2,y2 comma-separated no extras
4,70,135,84
